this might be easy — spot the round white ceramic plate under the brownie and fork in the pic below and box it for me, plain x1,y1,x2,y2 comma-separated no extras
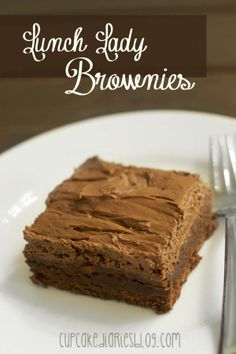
0,111,233,354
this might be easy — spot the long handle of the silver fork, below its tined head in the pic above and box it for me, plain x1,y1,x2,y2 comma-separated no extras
219,214,236,354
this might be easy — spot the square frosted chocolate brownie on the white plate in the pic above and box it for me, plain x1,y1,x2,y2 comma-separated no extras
24,157,216,313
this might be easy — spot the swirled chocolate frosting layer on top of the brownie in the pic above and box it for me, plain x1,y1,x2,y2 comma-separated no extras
25,157,211,267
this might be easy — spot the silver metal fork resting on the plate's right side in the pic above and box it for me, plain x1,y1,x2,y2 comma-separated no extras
210,135,236,354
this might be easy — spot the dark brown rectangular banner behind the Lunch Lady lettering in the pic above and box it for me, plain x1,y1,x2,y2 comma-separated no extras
0,15,206,77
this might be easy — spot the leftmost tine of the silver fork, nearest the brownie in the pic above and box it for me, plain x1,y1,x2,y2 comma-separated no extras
210,136,222,192
